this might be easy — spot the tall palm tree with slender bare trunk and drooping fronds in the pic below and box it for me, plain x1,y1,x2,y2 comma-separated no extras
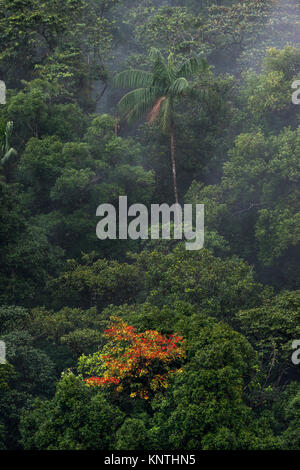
114,48,208,204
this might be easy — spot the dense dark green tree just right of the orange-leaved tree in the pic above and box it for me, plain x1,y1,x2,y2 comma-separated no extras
151,322,272,450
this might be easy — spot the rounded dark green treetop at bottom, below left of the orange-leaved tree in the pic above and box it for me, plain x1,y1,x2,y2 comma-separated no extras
21,373,123,450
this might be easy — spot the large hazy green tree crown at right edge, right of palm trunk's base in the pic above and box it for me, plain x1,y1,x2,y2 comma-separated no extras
187,119,300,288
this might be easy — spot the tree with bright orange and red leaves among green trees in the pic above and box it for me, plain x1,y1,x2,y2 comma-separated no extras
79,317,185,400
